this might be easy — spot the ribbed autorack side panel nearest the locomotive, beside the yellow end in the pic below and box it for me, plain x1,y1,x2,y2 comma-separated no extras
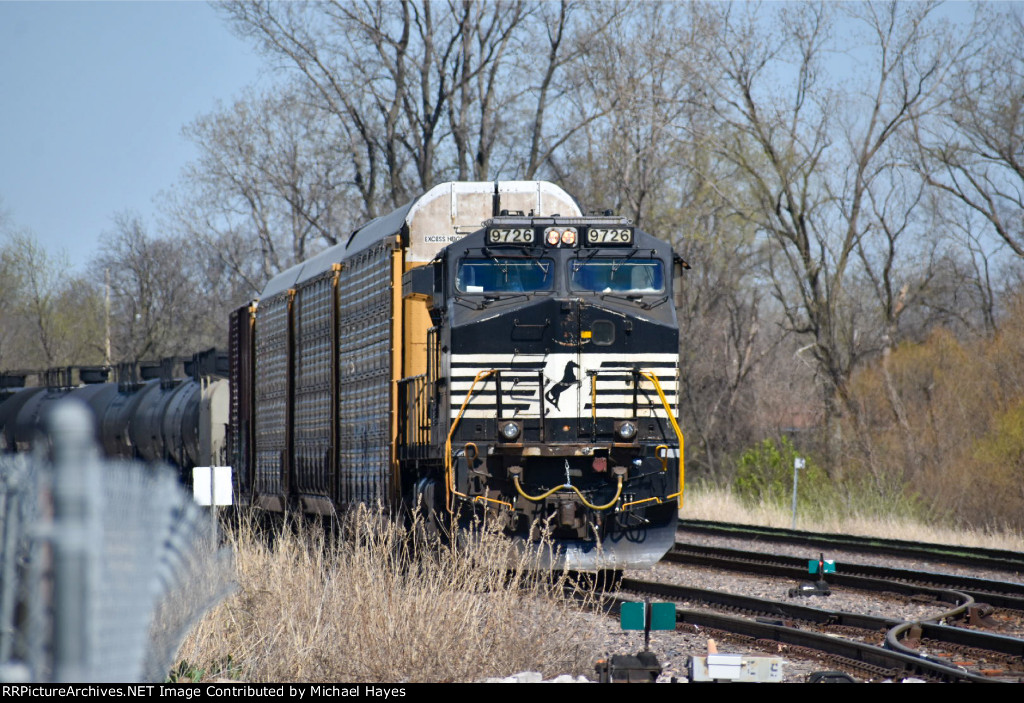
338,238,394,506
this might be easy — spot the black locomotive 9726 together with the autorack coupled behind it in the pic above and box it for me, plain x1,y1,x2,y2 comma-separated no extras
228,181,683,570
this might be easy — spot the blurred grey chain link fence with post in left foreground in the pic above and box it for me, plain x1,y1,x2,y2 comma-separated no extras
0,401,233,683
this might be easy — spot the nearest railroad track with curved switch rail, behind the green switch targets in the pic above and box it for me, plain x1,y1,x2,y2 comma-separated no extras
622,578,1024,683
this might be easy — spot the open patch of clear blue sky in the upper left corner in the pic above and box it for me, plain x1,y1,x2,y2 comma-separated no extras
0,0,265,267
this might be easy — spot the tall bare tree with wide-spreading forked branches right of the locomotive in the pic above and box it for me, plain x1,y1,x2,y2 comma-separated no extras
705,3,970,466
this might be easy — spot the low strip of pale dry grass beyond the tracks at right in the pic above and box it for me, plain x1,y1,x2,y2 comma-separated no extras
679,488,1024,552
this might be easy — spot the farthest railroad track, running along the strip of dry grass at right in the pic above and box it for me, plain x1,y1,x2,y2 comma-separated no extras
679,520,1024,574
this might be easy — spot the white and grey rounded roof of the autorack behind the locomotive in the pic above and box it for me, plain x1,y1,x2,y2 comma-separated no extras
260,181,579,300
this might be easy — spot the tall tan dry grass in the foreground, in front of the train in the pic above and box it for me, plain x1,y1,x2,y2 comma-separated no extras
173,511,599,683
